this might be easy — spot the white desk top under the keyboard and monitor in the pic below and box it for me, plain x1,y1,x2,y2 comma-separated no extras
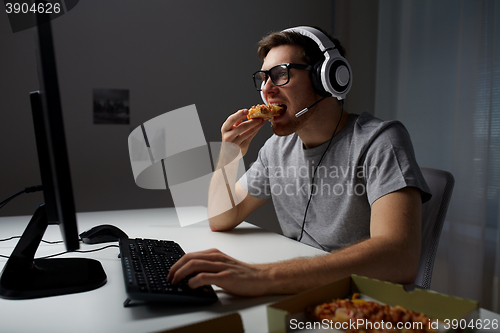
0,208,324,333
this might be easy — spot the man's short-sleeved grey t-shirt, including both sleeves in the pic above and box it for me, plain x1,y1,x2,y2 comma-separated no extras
240,113,431,251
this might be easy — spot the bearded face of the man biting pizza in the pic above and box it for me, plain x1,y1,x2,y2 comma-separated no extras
262,45,319,136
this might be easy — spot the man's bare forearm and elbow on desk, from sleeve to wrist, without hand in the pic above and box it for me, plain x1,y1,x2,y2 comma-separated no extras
262,188,422,293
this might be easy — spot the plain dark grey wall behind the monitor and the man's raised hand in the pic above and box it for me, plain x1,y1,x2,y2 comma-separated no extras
0,0,333,230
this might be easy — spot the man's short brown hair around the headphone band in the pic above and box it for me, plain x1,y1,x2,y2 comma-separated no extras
257,27,345,65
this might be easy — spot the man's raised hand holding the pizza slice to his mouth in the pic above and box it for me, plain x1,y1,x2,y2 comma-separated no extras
221,109,265,156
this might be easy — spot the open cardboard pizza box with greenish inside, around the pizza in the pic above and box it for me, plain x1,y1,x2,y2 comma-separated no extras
267,275,479,333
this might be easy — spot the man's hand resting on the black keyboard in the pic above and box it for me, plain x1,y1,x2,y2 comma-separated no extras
167,249,268,296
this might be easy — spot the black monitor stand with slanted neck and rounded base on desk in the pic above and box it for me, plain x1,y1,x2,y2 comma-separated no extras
0,205,107,299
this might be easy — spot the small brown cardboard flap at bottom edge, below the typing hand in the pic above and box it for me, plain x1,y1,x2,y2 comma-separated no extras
157,313,244,333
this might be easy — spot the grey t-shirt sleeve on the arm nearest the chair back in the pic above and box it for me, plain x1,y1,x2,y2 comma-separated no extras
363,122,431,205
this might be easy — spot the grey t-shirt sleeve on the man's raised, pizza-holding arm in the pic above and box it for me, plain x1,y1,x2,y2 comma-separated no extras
239,143,271,199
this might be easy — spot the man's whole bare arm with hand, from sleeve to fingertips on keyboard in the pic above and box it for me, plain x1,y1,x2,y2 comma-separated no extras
168,188,422,296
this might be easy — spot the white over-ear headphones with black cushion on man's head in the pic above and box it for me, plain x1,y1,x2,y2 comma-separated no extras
283,26,352,100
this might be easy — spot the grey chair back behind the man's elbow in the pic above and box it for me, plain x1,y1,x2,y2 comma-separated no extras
414,168,455,289
